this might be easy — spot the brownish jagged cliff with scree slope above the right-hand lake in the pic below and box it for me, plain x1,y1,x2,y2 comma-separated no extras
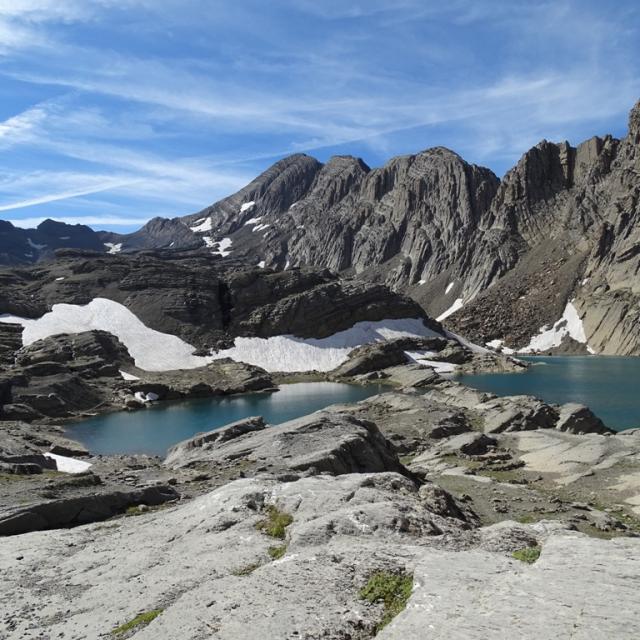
450,103,640,355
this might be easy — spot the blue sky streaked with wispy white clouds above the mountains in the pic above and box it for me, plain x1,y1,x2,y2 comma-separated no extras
0,0,640,231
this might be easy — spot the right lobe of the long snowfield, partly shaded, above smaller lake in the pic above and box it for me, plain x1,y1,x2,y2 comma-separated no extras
214,318,440,372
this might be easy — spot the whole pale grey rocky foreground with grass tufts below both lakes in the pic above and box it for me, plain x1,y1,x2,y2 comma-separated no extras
0,376,640,640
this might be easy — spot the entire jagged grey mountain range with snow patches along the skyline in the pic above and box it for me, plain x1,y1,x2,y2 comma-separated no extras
0,102,640,355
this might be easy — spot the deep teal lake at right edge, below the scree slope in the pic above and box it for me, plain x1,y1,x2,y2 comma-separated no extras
456,356,640,430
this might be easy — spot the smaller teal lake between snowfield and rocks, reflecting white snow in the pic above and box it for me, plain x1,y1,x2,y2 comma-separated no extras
66,382,385,456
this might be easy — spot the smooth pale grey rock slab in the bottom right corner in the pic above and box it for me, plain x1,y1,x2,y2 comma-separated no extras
376,533,640,640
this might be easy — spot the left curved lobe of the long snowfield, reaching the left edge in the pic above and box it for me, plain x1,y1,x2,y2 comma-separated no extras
0,298,211,371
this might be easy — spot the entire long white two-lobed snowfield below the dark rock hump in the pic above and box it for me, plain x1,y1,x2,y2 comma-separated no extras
0,298,439,372
